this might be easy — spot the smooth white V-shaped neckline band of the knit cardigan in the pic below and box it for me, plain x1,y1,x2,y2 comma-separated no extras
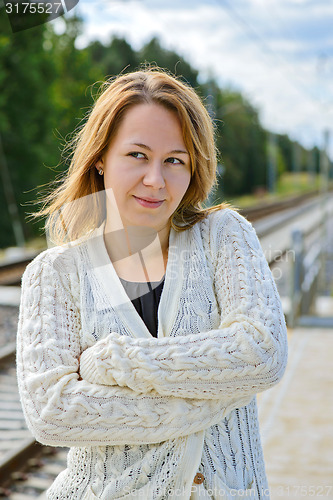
86,220,189,338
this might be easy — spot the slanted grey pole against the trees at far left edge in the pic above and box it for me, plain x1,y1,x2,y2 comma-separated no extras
0,134,25,247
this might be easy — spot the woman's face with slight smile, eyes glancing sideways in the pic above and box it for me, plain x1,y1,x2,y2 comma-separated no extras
96,104,191,231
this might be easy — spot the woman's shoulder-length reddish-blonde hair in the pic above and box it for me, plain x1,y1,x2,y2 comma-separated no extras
30,68,230,244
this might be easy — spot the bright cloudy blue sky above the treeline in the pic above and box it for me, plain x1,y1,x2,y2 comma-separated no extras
57,0,333,158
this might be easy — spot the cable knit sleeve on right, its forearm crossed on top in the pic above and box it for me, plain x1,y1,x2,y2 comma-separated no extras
80,210,287,404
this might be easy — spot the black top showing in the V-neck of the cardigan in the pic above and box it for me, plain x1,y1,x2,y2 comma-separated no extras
119,276,165,337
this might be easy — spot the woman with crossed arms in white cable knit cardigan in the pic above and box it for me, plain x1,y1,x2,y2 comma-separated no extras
17,69,287,500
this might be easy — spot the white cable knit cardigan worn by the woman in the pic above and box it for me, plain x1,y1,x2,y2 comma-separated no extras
17,209,287,500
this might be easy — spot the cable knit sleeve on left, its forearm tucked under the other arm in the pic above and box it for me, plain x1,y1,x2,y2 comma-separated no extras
17,250,249,446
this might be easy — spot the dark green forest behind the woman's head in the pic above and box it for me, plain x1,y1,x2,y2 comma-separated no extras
0,9,319,248
